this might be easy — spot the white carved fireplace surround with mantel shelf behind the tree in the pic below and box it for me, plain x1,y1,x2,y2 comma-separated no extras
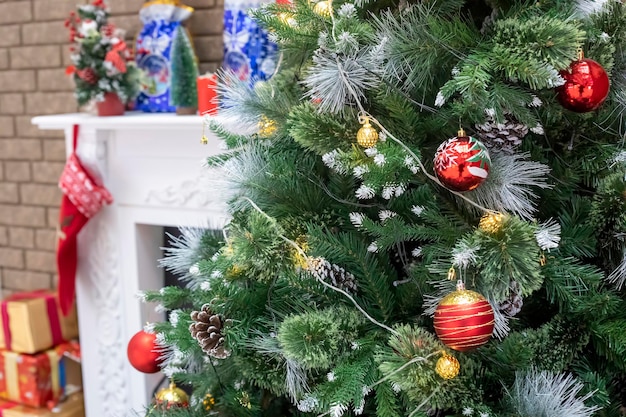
32,113,227,417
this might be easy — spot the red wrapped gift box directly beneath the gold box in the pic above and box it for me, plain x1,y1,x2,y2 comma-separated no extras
0,344,70,407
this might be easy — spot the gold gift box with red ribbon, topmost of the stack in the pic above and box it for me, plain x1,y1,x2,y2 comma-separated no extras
0,290,78,353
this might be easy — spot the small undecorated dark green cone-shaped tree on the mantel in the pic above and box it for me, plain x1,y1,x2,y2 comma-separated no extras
170,26,198,113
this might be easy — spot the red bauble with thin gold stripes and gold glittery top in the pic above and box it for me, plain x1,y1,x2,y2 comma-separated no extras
434,287,494,352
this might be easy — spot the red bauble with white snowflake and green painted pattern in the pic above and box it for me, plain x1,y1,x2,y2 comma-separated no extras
434,130,491,191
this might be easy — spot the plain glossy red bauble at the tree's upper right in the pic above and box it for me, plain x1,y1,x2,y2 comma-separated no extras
557,59,609,113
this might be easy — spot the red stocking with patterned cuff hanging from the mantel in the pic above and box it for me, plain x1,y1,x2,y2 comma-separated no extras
57,125,113,315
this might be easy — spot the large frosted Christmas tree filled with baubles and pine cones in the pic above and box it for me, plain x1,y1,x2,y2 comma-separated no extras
145,0,626,417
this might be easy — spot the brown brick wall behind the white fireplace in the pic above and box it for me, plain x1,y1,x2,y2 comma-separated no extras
0,0,223,295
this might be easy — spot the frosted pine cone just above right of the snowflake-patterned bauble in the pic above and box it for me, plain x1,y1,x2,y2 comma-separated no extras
474,114,528,154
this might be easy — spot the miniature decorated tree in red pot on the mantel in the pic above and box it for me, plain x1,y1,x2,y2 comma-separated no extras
65,0,140,116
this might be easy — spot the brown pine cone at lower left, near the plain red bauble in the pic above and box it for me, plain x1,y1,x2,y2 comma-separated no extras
189,304,230,359
